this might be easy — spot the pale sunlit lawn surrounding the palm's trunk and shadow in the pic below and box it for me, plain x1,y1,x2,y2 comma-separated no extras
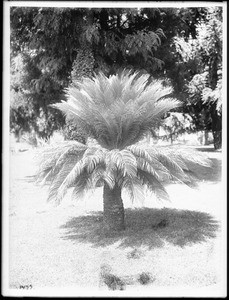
5,147,225,296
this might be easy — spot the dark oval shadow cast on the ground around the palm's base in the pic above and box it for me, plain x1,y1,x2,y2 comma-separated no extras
61,208,219,248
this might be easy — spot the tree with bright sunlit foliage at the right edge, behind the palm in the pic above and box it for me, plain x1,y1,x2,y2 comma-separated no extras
153,7,222,149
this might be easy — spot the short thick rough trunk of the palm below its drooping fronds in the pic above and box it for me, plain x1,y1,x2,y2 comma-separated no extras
103,183,125,231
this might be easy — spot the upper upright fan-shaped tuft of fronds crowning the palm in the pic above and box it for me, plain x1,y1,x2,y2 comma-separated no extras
53,71,180,149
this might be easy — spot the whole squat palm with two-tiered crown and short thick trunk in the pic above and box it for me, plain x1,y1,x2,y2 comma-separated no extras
39,71,209,230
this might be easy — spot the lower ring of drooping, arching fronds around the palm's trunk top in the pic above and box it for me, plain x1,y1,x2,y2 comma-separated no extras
36,141,210,203
